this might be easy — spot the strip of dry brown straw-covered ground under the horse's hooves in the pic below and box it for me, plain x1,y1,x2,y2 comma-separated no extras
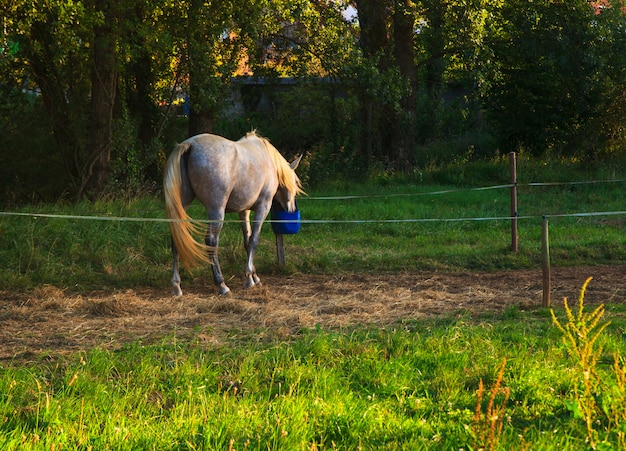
0,265,626,361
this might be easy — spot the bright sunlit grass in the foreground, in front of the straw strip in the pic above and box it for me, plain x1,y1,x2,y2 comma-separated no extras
0,307,626,450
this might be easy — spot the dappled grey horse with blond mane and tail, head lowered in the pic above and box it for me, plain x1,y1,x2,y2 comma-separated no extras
163,132,304,296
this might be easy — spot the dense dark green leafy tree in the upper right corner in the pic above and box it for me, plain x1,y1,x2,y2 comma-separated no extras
482,0,625,155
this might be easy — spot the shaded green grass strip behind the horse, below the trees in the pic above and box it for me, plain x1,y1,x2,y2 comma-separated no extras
0,163,626,290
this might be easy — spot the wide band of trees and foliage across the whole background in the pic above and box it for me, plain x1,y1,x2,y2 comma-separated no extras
0,0,626,203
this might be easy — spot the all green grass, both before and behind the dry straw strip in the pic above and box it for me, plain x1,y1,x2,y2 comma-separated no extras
0,159,626,450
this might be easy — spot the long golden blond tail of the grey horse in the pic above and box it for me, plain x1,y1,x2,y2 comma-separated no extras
163,143,211,270
